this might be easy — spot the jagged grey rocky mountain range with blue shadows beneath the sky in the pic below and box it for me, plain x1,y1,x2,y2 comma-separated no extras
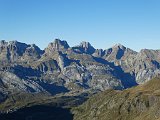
0,39,160,94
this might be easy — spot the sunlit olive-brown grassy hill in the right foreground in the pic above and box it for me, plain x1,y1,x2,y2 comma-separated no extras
73,78,160,120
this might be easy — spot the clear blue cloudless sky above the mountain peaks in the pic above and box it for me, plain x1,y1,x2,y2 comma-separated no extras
0,0,160,51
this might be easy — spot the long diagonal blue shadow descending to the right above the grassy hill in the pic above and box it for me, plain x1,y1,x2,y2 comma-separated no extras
93,57,138,89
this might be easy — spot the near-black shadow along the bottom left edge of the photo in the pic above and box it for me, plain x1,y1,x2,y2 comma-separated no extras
0,105,73,120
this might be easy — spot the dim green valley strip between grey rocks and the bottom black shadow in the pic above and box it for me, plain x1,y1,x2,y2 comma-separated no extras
0,93,88,113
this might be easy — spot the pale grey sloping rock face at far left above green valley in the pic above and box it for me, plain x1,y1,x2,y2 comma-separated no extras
0,71,44,92
